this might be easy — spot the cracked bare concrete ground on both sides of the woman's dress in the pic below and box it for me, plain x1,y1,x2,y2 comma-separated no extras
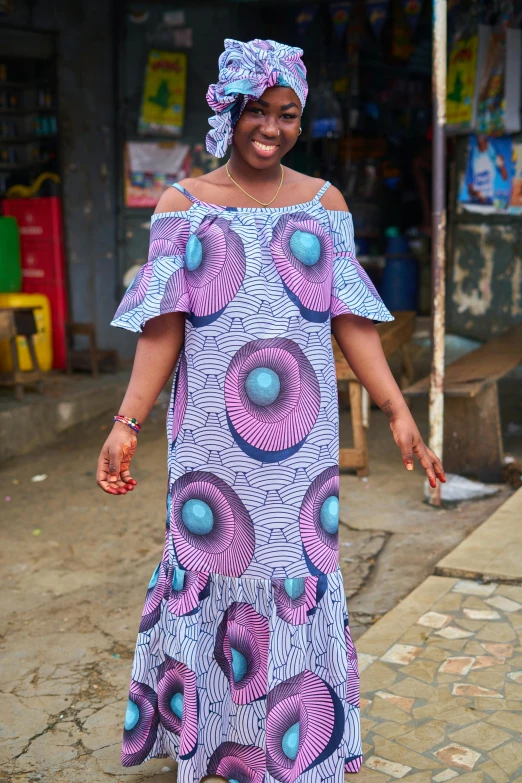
0,386,508,783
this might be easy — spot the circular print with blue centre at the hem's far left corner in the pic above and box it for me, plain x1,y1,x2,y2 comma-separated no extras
121,680,159,767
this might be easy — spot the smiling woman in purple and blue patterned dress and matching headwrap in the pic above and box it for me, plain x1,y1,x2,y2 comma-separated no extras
97,40,444,783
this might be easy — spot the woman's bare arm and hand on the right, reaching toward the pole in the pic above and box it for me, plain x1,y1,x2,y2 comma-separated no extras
332,315,446,487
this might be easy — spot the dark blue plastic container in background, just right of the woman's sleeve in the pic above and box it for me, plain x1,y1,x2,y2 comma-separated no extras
380,235,419,310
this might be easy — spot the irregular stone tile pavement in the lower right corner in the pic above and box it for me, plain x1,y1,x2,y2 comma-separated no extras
347,490,522,783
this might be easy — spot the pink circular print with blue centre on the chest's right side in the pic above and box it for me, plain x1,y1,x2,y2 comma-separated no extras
270,212,334,323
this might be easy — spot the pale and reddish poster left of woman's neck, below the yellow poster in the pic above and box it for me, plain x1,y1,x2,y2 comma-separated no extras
125,141,190,208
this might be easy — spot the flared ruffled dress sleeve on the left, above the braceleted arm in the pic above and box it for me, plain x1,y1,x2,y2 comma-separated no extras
112,214,190,332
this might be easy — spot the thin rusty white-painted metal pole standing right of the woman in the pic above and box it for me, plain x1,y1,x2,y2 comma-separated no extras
429,0,447,506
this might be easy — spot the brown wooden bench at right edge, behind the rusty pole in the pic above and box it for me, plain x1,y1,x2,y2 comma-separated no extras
403,323,522,481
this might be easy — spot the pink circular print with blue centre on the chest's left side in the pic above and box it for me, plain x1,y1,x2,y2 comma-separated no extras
185,216,246,327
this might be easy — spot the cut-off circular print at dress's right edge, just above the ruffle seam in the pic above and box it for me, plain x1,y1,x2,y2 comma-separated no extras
299,465,339,574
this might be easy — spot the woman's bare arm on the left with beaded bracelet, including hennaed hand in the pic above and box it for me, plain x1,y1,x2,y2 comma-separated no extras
96,313,185,495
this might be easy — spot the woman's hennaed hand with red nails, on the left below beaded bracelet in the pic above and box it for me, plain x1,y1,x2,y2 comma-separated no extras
96,422,138,495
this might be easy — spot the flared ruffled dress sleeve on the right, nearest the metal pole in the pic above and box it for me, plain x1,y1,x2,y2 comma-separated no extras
329,211,393,321
